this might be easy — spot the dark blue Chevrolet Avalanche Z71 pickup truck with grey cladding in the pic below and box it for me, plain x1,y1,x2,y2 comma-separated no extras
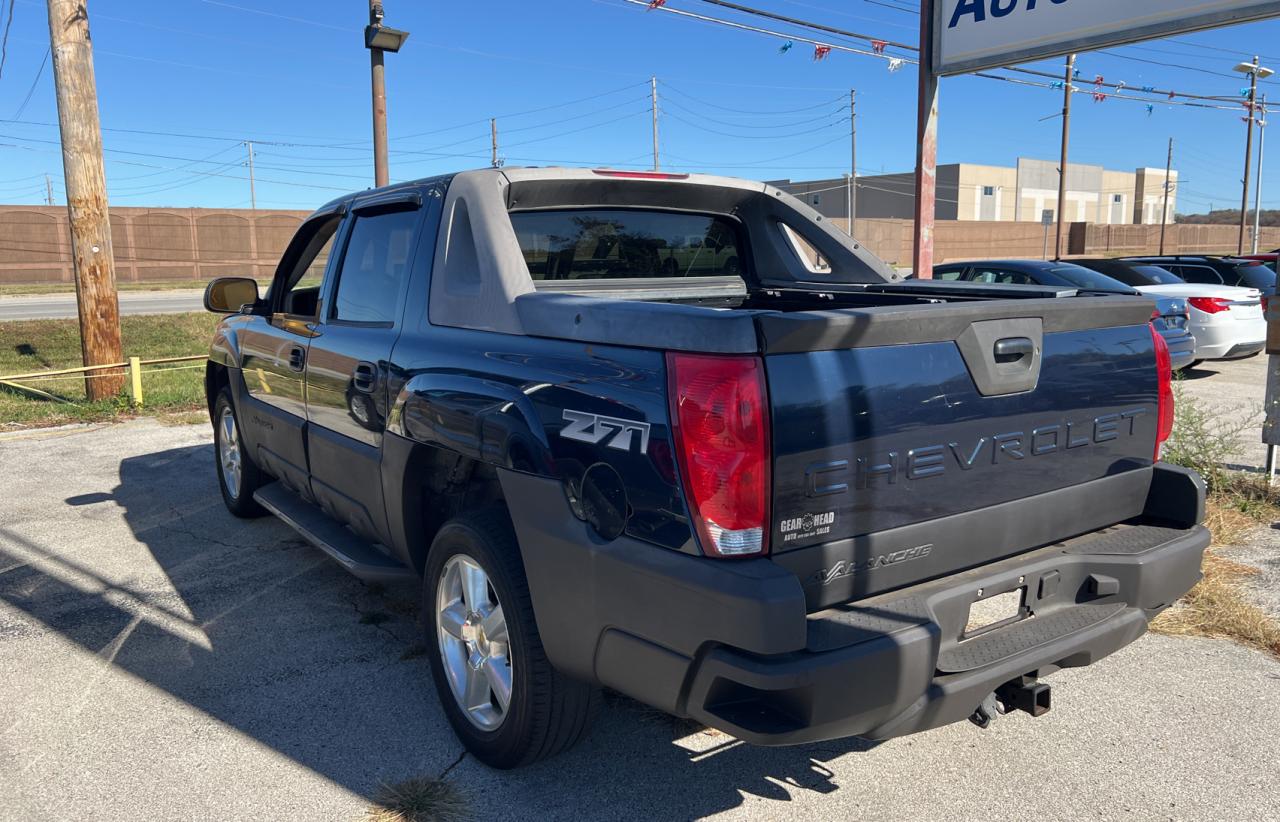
205,169,1208,767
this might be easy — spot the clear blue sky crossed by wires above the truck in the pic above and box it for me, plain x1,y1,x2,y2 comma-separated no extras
0,0,1280,213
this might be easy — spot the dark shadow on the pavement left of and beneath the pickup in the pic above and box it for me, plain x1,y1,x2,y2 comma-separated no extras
0,446,873,818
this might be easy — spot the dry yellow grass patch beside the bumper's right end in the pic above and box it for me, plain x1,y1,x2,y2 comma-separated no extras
1151,486,1280,657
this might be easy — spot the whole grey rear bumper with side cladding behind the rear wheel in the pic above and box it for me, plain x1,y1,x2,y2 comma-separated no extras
502,465,1208,745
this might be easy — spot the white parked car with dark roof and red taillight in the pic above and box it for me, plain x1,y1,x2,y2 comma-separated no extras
1071,259,1267,365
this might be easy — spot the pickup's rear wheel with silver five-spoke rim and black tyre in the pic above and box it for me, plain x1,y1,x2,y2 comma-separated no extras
422,507,599,768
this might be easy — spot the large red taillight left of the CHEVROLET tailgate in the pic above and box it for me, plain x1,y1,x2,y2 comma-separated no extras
667,353,769,557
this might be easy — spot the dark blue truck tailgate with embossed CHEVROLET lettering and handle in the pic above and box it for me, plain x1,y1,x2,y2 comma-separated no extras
759,297,1158,608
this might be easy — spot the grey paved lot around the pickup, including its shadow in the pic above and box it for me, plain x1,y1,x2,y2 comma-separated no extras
0,420,1280,822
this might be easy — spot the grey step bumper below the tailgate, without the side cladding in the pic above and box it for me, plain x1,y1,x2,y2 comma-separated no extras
685,526,1208,745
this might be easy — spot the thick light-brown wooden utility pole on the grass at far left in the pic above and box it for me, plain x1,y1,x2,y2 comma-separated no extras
49,0,124,401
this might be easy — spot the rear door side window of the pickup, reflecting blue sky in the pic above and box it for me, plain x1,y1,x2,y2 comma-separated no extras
329,209,419,324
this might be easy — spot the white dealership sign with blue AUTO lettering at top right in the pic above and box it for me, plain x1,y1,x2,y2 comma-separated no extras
933,0,1280,74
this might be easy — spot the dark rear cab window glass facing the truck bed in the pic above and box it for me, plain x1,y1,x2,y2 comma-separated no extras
511,209,745,280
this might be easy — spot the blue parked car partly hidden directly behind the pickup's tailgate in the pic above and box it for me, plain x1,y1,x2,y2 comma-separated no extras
933,260,1196,371
